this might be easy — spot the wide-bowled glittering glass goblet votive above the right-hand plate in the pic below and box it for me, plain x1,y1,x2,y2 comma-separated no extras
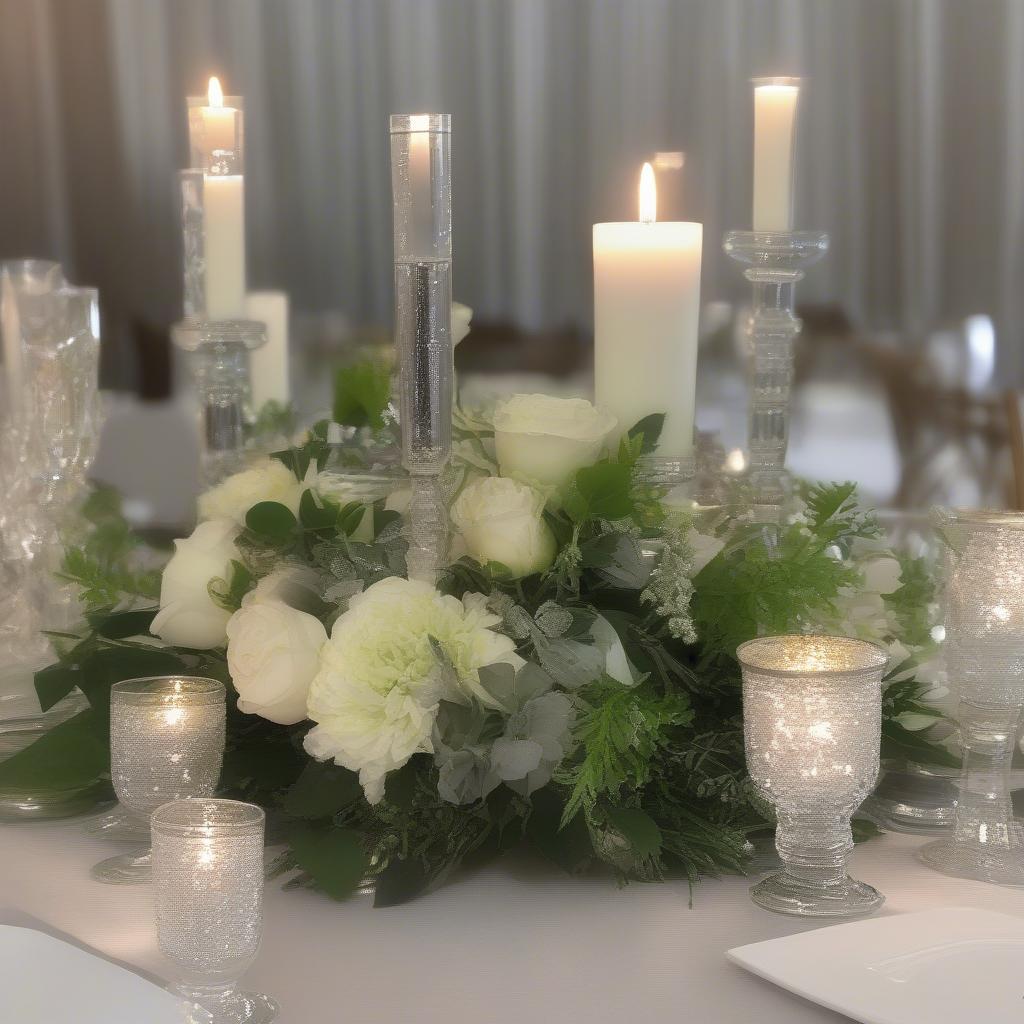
736,636,888,918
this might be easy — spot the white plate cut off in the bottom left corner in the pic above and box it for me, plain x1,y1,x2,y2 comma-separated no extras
0,925,184,1024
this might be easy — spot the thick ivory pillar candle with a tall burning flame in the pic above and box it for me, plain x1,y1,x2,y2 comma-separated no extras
594,164,703,458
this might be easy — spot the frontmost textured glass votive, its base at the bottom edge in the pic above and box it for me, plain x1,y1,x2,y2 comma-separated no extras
153,800,278,1024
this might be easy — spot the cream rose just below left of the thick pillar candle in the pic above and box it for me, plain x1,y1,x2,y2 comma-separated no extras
495,394,617,489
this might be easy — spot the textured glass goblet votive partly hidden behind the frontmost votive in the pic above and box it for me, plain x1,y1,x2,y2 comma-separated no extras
92,676,226,883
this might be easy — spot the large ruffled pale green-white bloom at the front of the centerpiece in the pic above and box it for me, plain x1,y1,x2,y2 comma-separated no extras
305,577,522,804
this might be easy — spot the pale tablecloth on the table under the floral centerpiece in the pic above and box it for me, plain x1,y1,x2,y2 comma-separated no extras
0,820,1024,1024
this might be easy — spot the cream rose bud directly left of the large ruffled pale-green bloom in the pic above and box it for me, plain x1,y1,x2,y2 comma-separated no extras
227,599,327,725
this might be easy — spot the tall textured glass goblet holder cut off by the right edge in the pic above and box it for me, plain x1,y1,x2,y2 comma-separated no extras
919,511,1024,886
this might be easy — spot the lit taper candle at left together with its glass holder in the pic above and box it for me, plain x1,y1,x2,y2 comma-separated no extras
179,78,267,486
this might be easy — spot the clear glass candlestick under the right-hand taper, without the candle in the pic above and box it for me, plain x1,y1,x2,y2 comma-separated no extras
724,231,828,523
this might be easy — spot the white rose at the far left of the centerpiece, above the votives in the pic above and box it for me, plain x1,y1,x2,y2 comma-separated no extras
151,519,240,650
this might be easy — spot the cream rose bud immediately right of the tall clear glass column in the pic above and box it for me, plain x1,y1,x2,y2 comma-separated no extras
452,476,555,577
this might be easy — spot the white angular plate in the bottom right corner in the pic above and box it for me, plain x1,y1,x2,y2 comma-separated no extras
726,907,1024,1024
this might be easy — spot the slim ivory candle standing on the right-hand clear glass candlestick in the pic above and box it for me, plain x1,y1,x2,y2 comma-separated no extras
754,78,800,231
